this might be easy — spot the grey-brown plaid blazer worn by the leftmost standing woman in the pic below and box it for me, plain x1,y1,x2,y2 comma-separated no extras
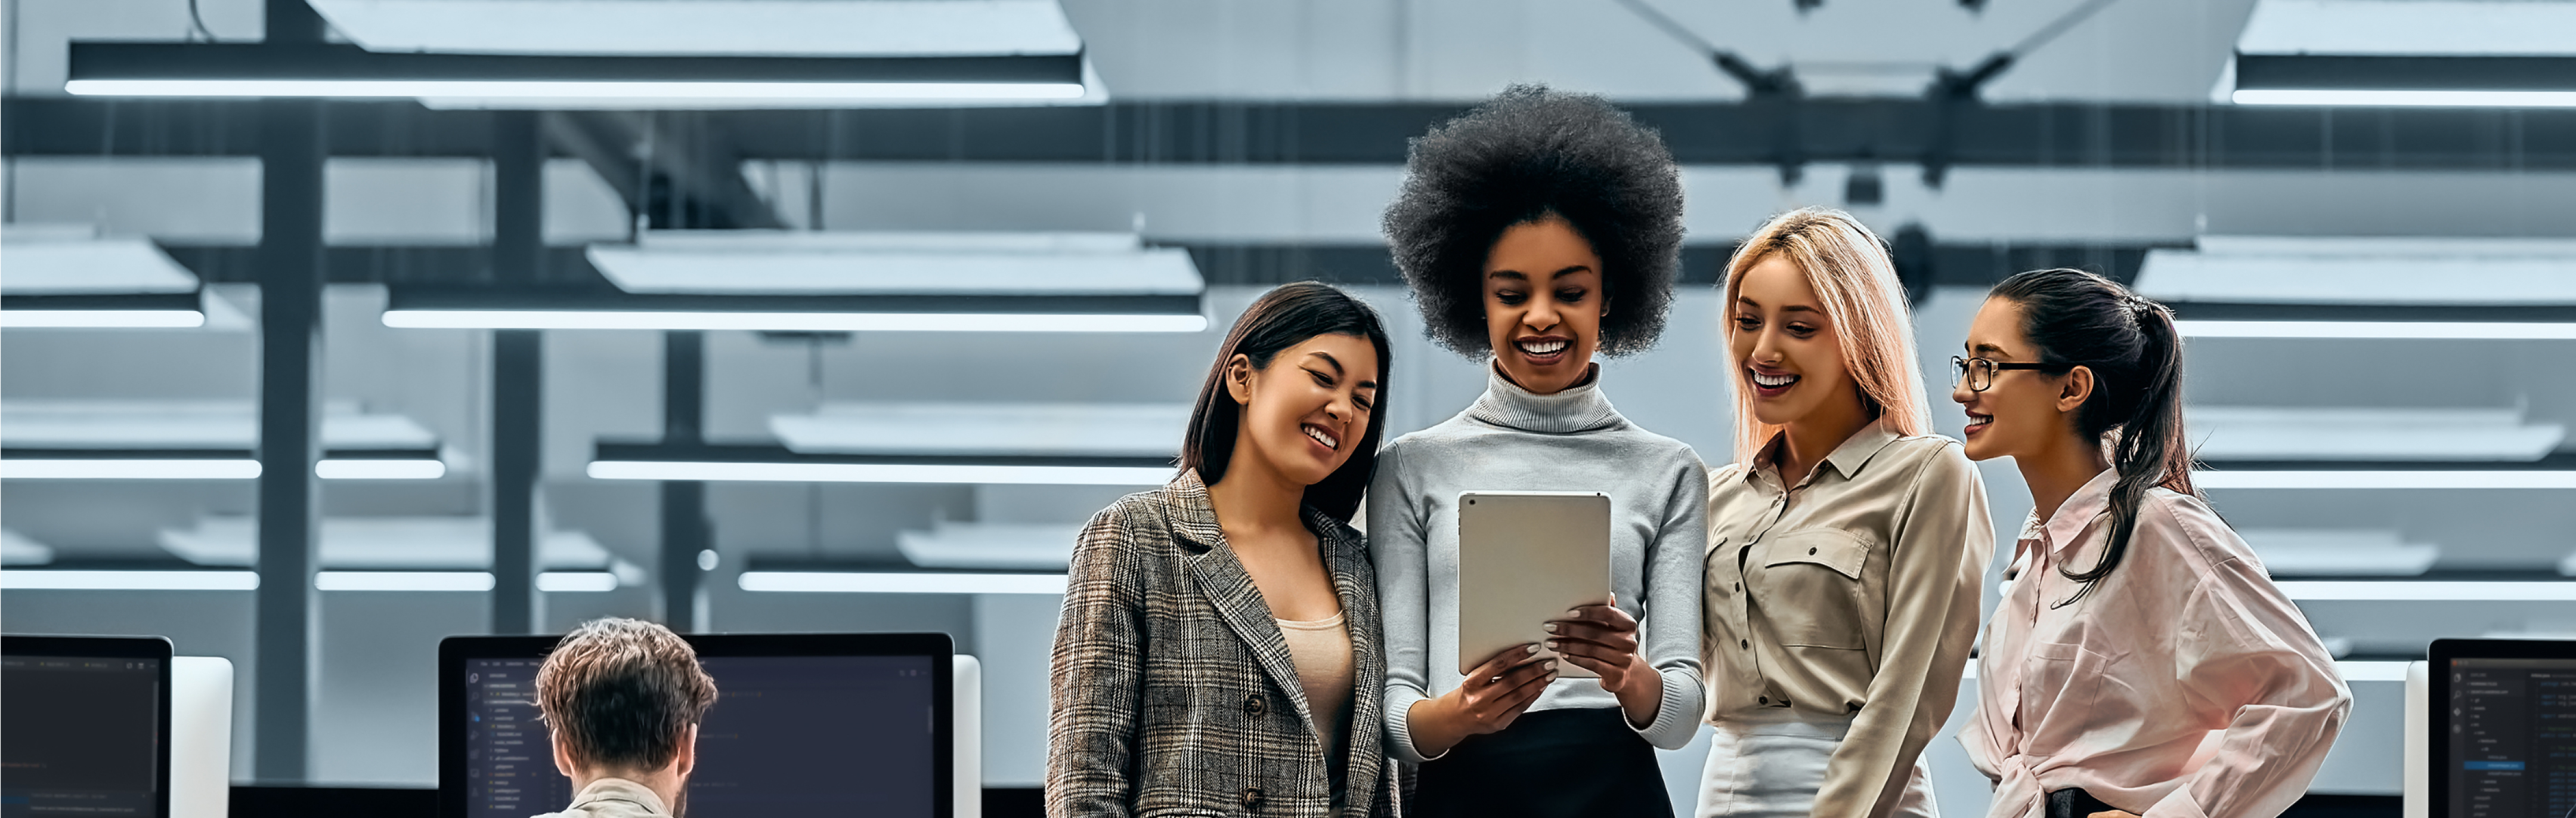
1046,470,1394,818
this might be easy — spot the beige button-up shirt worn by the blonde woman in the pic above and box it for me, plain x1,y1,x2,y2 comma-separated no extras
1700,423,1994,818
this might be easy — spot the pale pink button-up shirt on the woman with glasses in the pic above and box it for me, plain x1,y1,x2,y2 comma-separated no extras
1958,470,2352,818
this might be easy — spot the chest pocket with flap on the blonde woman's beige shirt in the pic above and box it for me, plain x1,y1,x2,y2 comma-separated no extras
1757,529,1870,650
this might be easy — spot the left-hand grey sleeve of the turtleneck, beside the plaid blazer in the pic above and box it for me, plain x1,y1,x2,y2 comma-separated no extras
1368,444,1438,764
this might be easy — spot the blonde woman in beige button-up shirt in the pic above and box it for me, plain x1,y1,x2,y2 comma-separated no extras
1698,209,1994,818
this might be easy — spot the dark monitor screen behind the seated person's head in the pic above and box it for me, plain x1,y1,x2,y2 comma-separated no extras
466,656,945,818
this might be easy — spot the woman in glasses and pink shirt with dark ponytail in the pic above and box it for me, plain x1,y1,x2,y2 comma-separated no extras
1950,268,2352,818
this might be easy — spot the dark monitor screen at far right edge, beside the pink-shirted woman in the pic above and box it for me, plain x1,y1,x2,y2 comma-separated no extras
2447,658,2576,818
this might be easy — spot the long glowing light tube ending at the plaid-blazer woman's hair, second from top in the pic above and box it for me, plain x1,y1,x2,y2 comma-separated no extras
384,310,1208,333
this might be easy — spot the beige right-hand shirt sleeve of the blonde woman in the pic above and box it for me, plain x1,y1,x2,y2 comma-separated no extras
1816,444,1994,818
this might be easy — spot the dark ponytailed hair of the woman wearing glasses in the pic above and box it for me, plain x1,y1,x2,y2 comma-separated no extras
1989,268,2200,604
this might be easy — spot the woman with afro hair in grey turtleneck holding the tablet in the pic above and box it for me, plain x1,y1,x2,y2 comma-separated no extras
1368,85,1708,816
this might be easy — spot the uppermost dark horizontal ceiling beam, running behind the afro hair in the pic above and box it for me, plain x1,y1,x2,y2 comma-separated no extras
0,98,2576,170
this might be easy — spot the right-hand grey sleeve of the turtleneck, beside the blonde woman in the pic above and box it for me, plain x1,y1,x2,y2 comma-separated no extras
1636,449,1708,751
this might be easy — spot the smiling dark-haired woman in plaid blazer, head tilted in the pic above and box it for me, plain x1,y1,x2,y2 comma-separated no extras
1046,281,1394,818
